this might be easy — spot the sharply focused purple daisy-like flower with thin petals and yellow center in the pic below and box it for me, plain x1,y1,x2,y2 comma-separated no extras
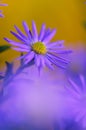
5,21,70,69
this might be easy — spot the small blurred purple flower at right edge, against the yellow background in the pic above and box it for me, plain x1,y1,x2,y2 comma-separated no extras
66,47,86,78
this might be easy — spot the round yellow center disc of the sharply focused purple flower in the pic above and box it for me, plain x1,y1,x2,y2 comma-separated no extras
32,42,47,55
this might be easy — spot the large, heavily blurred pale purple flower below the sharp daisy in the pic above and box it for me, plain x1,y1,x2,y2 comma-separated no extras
0,67,67,130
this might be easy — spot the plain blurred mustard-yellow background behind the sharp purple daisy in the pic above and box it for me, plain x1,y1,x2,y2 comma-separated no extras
0,0,86,67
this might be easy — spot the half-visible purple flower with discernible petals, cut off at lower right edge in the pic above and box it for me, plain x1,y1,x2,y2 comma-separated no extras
66,75,86,128
